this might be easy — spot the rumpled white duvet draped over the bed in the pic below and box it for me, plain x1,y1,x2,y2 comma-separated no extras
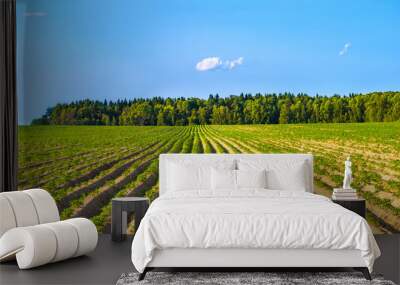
132,189,380,272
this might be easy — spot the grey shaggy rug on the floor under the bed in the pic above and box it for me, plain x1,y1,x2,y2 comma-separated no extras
117,272,395,285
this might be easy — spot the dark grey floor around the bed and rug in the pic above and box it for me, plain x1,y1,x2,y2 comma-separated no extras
0,234,400,285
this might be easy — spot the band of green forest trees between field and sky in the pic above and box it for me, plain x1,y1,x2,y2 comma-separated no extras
32,92,400,126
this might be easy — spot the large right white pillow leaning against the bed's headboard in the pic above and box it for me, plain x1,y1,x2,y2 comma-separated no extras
238,160,308,192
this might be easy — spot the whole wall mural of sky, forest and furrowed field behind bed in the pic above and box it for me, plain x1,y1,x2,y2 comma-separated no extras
17,0,400,233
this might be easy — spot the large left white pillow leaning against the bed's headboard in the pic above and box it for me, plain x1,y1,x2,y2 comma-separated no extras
166,159,236,191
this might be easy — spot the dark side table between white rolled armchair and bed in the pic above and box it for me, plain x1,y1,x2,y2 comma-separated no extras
111,197,149,241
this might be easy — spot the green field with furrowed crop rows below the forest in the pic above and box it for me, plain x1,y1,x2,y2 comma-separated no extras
19,122,400,233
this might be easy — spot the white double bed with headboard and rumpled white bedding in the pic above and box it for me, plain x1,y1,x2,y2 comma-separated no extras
132,154,380,278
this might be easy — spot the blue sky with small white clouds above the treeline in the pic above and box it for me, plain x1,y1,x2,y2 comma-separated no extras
17,0,400,124
